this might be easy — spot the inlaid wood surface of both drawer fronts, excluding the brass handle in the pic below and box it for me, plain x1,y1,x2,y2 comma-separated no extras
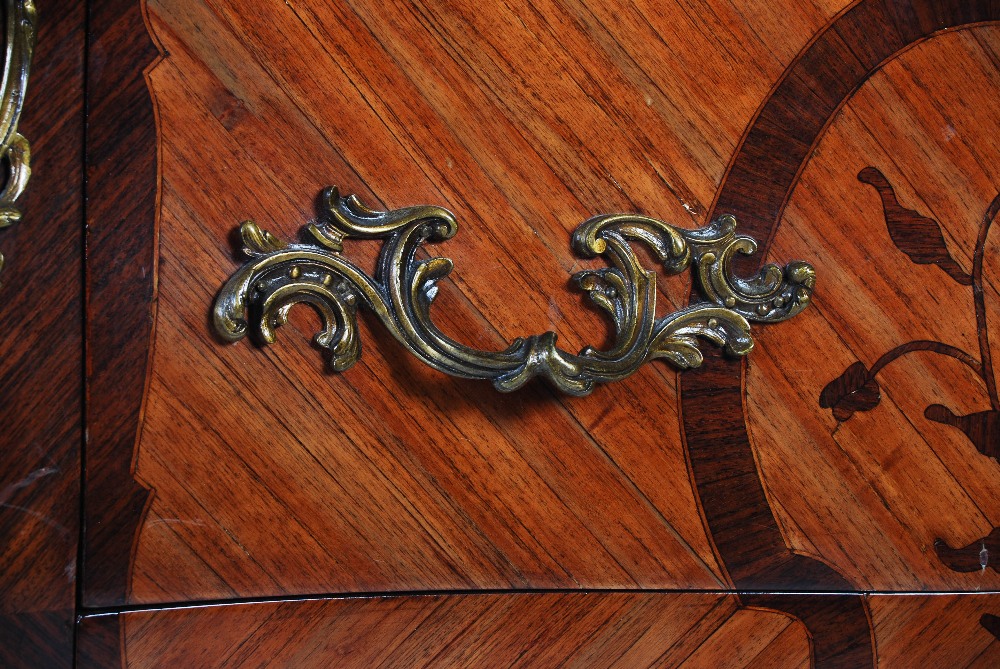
77,0,1000,667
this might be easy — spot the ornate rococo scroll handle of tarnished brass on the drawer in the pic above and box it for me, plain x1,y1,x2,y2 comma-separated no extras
213,187,815,395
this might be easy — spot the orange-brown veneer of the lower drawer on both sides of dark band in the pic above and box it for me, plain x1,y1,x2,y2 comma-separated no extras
83,593,1000,669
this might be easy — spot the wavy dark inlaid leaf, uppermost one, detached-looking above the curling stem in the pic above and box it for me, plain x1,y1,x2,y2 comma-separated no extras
858,167,972,286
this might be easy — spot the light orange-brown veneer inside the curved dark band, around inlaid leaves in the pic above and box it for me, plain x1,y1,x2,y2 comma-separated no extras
746,26,1000,590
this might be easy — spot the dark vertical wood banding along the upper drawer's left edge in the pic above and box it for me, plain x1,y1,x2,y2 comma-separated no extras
81,0,159,606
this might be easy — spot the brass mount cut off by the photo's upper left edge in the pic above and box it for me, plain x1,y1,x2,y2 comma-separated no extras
0,0,35,268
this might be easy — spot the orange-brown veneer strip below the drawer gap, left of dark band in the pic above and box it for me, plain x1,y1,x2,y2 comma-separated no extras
115,593,780,667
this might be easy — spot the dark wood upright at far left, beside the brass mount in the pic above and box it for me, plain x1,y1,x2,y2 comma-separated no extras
0,6,84,667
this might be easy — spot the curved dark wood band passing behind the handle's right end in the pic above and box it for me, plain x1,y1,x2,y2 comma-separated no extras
680,0,1000,667
